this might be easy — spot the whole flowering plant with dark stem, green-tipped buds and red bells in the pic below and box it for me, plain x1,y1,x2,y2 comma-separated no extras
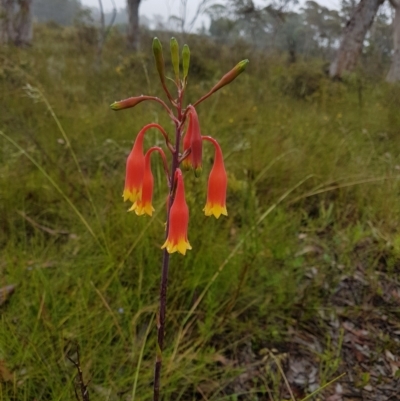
110,38,248,401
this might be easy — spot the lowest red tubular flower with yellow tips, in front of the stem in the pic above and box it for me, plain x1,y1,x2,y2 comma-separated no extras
161,169,192,255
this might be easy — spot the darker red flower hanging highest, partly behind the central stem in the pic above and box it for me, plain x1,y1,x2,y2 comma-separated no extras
182,106,203,177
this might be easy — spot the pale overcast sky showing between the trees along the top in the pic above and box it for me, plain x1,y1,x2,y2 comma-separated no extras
81,0,340,27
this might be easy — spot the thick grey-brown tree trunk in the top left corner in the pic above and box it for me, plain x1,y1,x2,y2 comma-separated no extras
0,0,33,46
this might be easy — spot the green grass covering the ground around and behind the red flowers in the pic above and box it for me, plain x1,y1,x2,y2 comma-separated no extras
0,27,400,401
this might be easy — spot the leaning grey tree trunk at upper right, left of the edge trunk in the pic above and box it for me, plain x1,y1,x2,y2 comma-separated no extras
329,0,384,78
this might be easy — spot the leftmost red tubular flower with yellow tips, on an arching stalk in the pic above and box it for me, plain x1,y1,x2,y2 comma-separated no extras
122,123,166,203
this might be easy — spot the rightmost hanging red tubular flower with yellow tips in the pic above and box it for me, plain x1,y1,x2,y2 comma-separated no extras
203,136,228,219
